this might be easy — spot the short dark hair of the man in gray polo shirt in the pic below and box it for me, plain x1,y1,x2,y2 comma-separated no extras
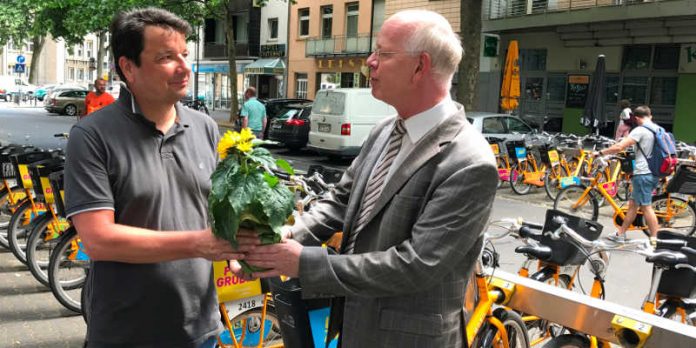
110,7,191,82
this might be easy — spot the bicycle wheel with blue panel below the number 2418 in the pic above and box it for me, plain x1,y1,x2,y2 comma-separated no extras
220,305,283,347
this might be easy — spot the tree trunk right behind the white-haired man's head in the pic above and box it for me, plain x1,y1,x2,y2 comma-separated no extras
457,0,483,111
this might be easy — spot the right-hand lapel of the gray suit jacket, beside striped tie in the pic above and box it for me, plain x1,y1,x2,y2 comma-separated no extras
368,107,468,223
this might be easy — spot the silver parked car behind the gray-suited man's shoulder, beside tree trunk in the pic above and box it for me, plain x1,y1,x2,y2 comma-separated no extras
466,112,534,140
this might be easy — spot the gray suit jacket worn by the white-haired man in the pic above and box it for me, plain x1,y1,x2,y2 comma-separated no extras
292,105,498,348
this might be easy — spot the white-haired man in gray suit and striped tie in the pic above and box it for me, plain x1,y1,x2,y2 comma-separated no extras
238,10,498,347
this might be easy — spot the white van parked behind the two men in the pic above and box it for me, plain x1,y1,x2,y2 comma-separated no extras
307,88,396,156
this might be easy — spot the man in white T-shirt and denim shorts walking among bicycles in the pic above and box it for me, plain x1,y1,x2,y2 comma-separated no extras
595,105,659,242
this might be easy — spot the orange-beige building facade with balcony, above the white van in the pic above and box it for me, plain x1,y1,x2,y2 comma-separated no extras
287,0,385,99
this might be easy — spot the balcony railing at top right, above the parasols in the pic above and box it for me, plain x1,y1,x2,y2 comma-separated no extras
484,0,674,19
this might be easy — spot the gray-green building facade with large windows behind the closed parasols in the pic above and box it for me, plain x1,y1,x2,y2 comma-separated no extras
479,0,696,142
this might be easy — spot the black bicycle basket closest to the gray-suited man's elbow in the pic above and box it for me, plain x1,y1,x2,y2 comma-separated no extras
540,209,604,266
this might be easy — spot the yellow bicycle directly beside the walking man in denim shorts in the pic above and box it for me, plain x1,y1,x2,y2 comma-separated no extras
553,157,696,236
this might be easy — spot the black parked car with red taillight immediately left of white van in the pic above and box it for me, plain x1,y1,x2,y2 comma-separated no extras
268,103,312,150
